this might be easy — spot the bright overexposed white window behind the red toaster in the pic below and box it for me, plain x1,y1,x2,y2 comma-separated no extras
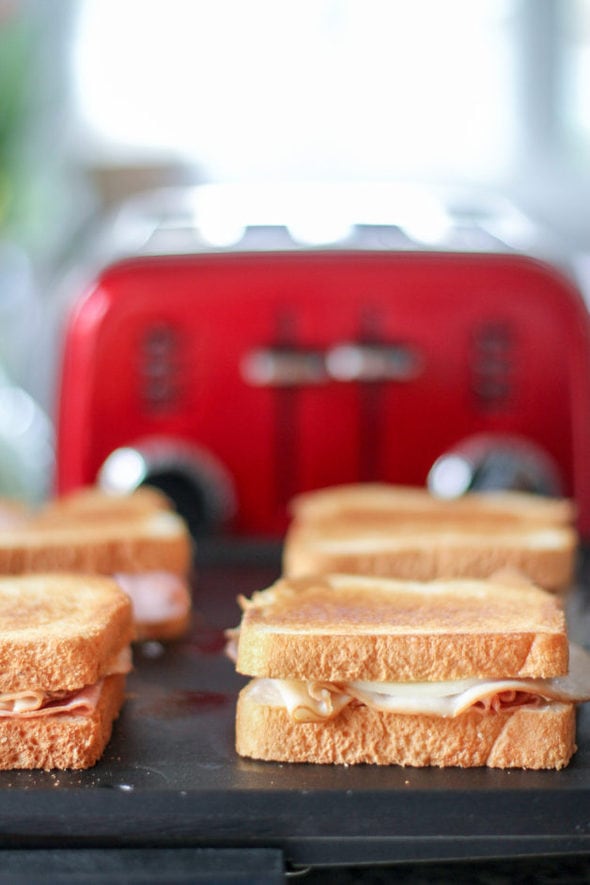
74,0,517,181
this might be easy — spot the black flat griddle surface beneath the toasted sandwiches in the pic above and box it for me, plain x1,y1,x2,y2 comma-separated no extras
0,547,590,883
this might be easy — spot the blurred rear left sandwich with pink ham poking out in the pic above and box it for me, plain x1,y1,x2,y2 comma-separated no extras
0,488,192,640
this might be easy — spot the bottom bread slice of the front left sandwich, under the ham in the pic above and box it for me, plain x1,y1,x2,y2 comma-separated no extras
0,676,125,770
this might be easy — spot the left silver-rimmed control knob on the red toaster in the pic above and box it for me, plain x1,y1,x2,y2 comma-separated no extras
98,438,236,535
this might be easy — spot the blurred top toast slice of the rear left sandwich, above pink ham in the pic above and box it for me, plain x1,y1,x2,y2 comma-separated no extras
0,510,192,575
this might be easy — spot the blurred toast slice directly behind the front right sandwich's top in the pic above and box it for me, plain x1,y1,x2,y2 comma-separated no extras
283,520,578,591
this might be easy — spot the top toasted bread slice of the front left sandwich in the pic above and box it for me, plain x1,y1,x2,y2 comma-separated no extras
0,574,135,692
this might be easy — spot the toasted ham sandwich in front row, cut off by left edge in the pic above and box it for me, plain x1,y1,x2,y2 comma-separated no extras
0,573,133,770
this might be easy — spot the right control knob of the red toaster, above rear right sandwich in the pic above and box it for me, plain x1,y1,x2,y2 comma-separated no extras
427,435,562,498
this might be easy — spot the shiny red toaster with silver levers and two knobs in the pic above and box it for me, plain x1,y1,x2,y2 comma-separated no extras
56,183,590,537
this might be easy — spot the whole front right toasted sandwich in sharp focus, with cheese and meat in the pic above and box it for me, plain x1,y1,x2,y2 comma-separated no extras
236,574,590,769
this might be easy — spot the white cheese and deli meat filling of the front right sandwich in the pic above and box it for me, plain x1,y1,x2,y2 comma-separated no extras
250,646,590,722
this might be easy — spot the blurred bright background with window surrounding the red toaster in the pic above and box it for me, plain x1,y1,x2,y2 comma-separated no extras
0,0,590,500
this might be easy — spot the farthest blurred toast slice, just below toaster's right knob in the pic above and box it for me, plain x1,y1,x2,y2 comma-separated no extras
290,483,576,526
